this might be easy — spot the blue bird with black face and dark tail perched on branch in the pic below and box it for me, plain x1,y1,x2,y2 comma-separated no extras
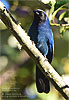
28,9,54,93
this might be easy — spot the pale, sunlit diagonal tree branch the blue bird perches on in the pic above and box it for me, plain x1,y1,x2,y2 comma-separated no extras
0,2,69,99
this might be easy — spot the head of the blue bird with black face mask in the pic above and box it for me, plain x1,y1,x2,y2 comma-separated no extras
33,9,47,22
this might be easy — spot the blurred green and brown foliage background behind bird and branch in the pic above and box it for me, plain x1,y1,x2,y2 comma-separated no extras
0,0,69,100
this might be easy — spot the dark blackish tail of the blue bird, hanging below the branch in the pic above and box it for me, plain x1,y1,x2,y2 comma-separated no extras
36,66,50,93
